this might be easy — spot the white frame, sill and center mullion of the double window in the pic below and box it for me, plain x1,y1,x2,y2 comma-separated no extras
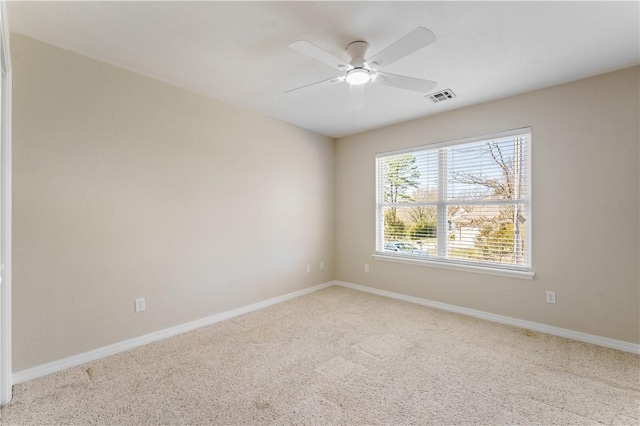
372,127,535,279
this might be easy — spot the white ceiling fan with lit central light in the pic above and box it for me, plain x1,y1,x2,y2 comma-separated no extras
284,27,436,93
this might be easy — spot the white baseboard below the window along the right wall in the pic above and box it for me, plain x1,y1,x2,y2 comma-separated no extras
335,281,640,354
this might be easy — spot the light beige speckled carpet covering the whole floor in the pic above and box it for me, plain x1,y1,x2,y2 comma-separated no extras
1,287,640,425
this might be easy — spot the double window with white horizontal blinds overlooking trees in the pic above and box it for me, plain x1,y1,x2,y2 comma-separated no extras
376,129,531,272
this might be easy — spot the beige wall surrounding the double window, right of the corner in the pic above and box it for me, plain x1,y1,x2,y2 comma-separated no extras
335,67,640,343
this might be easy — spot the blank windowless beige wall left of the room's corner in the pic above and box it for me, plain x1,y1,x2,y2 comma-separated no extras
11,34,334,371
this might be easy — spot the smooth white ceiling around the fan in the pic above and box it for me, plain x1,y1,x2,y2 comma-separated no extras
8,1,640,138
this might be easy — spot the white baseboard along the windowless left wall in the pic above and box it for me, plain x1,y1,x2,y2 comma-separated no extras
11,281,335,384
